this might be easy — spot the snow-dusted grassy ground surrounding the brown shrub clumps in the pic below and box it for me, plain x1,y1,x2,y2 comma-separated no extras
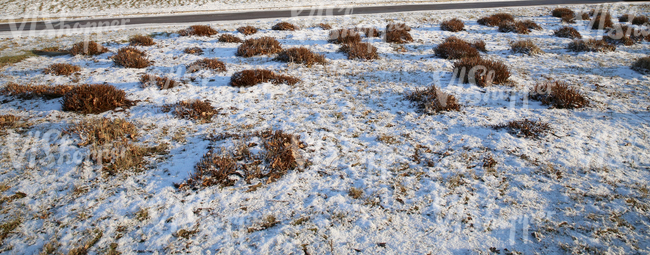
0,2,650,254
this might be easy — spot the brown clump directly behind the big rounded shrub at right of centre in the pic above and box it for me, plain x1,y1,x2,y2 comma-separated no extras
433,36,485,59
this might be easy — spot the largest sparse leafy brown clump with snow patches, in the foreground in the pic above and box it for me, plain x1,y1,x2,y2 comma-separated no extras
175,130,305,190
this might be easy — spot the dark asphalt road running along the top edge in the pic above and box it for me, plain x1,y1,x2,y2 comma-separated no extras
0,0,620,32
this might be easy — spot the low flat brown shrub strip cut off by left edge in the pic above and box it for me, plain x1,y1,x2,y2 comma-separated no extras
0,83,75,99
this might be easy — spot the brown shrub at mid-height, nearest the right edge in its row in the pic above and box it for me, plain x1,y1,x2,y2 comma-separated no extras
530,81,589,109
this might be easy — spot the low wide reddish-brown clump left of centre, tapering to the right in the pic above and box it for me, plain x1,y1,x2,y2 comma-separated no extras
230,69,300,87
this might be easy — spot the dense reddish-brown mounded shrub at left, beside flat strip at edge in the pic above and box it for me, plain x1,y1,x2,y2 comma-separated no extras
62,84,134,114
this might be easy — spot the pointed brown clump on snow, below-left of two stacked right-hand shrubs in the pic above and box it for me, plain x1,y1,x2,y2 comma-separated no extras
406,85,460,114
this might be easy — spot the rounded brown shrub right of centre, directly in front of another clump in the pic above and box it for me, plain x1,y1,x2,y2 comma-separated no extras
454,57,510,87
